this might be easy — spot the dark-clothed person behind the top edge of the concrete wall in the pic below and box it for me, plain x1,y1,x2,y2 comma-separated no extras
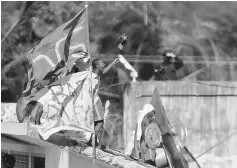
154,50,183,80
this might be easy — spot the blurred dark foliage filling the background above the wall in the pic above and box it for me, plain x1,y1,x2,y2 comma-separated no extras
1,1,237,101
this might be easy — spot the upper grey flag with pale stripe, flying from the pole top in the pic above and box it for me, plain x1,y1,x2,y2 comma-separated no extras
24,7,89,95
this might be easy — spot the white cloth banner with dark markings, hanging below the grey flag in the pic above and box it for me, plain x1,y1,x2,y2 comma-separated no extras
34,71,99,140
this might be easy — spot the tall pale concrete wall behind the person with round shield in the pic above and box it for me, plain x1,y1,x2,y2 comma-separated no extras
123,81,237,168
